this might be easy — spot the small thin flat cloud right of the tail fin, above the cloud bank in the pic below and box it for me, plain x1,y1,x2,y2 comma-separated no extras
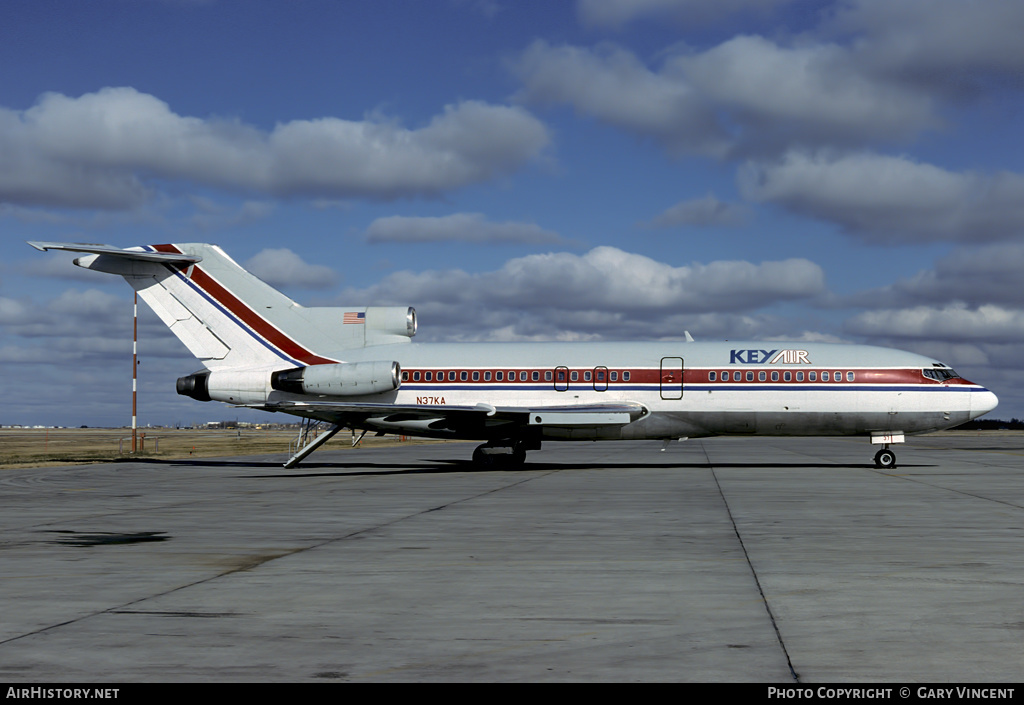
366,213,561,244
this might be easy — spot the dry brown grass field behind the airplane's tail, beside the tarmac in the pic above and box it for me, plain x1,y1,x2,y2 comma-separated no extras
0,428,428,468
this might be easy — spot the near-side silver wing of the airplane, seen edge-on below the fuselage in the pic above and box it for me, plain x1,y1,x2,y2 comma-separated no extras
257,401,647,430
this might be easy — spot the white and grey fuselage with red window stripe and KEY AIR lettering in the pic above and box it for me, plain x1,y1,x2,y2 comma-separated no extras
301,341,996,440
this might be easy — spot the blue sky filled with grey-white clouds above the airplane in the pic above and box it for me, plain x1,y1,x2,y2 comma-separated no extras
0,0,1024,426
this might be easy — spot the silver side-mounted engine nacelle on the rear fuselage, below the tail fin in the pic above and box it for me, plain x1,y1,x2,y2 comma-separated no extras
270,361,401,397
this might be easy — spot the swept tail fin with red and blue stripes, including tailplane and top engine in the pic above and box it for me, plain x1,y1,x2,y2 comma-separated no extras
30,243,416,370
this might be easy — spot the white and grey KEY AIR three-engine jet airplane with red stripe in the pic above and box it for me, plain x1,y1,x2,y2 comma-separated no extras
29,242,998,468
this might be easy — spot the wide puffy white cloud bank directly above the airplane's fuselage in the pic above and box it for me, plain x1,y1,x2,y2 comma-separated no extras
327,247,824,339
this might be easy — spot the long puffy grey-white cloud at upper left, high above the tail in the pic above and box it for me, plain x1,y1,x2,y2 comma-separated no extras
0,88,549,208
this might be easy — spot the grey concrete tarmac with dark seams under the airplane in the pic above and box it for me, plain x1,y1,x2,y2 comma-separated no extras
0,433,1024,685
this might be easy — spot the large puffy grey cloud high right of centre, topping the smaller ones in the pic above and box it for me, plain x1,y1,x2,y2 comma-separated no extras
513,36,939,158
